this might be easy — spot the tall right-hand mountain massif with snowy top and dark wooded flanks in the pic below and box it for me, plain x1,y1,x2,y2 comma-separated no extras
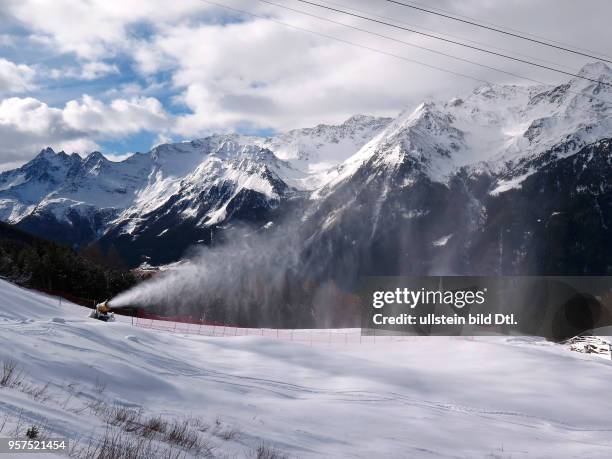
306,64,612,282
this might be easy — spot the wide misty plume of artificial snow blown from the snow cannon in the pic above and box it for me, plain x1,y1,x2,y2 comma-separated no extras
111,225,360,327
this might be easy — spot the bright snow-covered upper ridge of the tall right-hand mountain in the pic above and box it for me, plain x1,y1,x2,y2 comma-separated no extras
318,62,612,190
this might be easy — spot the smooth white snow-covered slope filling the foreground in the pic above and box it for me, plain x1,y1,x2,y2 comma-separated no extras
0,281,612,459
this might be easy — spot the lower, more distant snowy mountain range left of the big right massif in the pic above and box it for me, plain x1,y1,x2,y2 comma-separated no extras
0,116,388,263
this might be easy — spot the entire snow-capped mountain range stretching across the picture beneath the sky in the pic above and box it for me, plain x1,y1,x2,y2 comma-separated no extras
0,63,612,274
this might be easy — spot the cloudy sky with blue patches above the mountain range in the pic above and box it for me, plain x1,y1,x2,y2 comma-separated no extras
0,0,612,171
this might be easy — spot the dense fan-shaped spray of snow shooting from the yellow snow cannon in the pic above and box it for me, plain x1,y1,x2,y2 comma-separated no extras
111,227,314,324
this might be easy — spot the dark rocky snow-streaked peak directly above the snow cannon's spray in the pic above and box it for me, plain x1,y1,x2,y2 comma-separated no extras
96,136,303,265
